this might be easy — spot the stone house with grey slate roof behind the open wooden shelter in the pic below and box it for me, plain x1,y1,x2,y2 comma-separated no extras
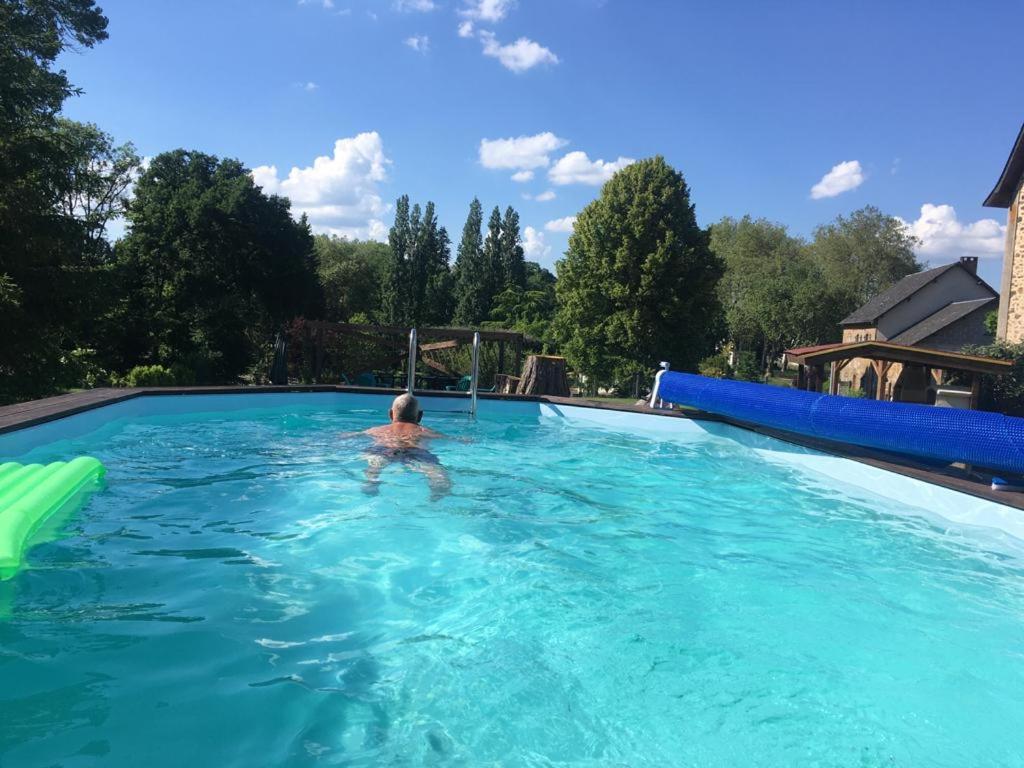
839,257,999,402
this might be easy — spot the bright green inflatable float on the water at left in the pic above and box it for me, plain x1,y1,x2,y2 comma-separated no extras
0,456,105,581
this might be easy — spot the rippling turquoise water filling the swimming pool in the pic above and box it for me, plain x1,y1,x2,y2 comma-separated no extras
0,408,1024,768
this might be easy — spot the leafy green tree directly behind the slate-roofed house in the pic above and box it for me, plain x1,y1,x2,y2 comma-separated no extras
811,206,922,319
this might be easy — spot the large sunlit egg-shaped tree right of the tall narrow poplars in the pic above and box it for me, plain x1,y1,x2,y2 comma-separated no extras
556,157,722,385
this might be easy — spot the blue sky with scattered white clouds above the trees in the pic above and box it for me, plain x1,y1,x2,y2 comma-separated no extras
61,0,1024,287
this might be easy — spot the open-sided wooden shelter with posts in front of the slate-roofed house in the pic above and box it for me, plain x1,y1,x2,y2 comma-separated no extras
785,341,1013,409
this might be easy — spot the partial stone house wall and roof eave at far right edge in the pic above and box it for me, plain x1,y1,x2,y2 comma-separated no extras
985,121,1024,344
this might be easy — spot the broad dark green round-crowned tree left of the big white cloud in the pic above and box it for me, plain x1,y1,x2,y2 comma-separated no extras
110,150,322,383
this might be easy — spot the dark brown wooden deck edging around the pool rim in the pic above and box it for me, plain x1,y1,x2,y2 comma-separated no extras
0,384,1024,510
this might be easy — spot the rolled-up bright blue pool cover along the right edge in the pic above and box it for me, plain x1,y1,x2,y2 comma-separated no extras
657,372,1024,474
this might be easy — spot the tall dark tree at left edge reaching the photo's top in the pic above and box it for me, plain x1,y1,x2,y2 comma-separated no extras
0,0,114,402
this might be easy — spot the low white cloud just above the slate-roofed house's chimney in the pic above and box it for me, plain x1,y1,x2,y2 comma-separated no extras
900,203,1007,260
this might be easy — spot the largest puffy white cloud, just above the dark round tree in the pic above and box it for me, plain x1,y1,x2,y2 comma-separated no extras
252,131,390,240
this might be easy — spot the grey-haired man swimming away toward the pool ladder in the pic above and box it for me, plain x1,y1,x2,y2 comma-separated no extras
361,393,452,500
